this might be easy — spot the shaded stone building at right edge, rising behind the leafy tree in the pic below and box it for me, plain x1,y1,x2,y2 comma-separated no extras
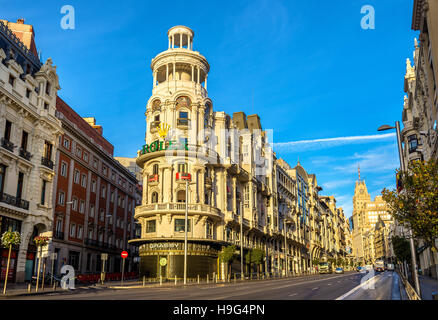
402,0,438,278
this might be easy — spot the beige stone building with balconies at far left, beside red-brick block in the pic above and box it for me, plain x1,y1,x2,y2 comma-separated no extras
0,19,62,282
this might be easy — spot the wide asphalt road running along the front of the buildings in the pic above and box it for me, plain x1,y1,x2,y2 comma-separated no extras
11,272,399,300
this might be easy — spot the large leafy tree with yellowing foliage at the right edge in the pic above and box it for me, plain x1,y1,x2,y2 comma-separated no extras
382,159,438,265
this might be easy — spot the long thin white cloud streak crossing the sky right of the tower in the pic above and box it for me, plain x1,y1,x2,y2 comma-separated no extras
274,133,395,153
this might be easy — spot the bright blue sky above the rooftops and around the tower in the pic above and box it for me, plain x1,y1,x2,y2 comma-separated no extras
0,0,417,216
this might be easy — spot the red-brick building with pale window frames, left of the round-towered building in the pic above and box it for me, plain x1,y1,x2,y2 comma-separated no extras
52,97,139,274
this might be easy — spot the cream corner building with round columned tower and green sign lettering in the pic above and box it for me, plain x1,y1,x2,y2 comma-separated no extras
130,26,345,279
